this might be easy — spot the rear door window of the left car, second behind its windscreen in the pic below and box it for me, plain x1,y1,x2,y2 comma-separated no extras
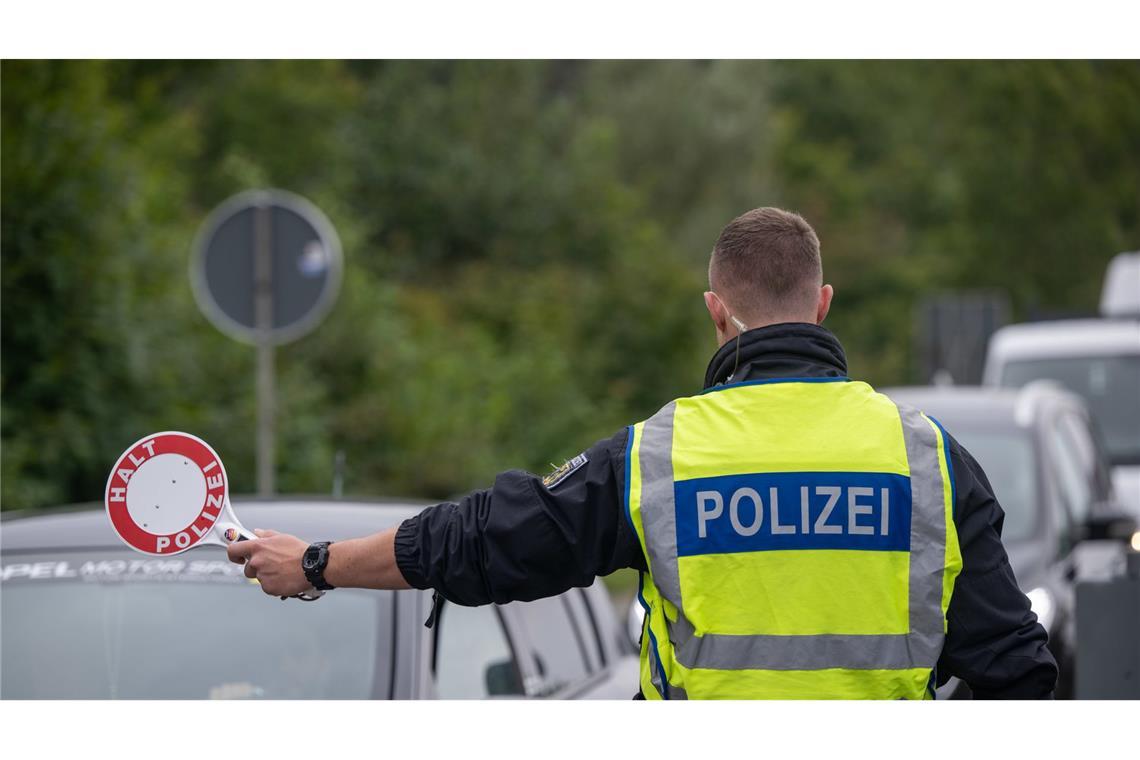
514,595,589,693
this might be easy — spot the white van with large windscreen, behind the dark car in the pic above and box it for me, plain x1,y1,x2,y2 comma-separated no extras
983,319,1140,517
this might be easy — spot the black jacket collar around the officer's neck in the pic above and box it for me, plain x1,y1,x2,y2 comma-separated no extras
705,322,847,390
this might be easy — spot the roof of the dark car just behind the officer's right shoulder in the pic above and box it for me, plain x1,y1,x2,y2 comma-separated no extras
880,381,1083,432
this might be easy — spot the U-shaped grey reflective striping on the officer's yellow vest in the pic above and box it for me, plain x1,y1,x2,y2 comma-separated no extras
638,403,946,669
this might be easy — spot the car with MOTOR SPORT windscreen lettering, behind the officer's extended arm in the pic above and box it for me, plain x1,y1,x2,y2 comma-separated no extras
0,500,637,700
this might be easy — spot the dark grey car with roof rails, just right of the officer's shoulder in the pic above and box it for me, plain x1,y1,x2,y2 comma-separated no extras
884,383,1134,697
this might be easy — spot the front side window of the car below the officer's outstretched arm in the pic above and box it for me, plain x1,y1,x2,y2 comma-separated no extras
434,602,523,700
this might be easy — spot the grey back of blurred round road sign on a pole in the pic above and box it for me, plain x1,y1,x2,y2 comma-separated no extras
190,190,343,345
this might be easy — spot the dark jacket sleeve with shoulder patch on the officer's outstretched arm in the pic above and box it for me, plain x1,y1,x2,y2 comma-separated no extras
396,430,645,606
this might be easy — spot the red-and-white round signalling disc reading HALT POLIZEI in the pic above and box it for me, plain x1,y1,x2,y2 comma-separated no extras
104,431,253,556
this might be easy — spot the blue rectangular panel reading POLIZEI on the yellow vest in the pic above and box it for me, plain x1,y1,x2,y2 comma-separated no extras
674,473,911,556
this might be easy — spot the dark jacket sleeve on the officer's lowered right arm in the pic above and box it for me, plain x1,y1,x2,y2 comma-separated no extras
937,434,1057,700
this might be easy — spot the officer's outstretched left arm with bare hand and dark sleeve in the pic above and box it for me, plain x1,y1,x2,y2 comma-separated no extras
229,431,644,605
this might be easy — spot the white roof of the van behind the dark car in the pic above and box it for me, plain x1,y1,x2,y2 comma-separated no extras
987,319,1140,363
